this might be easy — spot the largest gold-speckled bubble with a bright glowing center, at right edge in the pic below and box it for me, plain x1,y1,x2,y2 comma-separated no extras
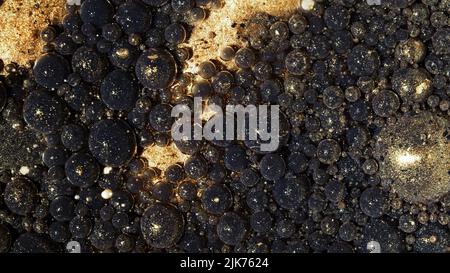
375,112,450,203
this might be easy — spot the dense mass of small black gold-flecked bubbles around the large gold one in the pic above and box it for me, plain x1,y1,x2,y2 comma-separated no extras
0,0,450,253
